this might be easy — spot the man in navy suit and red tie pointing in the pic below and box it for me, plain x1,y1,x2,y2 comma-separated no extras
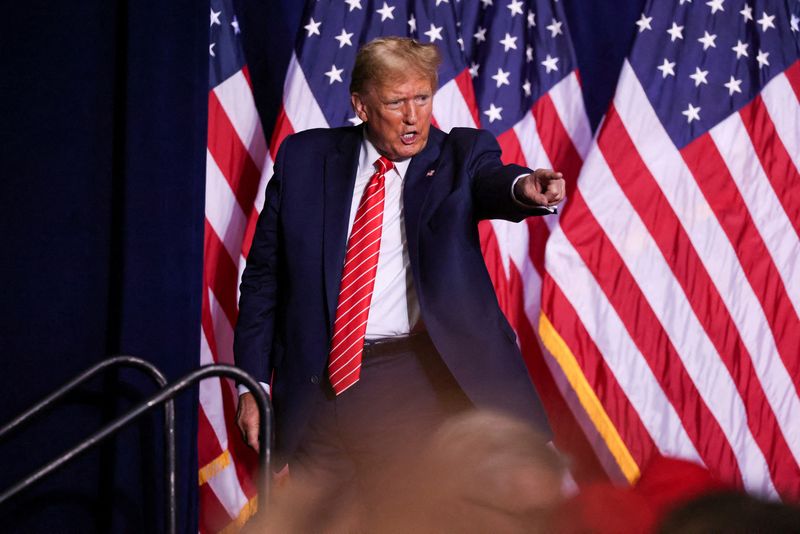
234,38,564,528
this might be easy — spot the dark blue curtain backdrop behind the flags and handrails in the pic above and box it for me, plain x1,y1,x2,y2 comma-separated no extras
0,0,644,533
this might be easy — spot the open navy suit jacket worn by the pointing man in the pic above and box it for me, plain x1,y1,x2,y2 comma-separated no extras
234,127,548,460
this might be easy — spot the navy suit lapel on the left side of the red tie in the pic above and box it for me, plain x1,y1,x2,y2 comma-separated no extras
322,128,363,334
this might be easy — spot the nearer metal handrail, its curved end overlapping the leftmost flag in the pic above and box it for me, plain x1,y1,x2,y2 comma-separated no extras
0,364,272,532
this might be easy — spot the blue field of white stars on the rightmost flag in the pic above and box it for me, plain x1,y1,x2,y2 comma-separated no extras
634,0,800,147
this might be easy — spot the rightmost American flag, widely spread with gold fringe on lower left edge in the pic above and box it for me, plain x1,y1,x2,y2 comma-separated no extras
539,0,800,500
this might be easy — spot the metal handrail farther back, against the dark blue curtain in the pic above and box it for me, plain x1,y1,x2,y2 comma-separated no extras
0,355,177,534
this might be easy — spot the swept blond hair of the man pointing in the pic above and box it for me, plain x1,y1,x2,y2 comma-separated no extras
350,37,442,93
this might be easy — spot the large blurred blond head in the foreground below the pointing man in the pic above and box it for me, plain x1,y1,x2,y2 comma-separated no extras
370,411,567,534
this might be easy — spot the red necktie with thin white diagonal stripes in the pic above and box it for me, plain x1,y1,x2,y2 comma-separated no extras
328,156,394,395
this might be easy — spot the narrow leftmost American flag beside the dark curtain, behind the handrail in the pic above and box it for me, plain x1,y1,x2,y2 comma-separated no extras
197,0,271,533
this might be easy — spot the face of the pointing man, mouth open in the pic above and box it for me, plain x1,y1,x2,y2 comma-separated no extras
351,76,433,161
